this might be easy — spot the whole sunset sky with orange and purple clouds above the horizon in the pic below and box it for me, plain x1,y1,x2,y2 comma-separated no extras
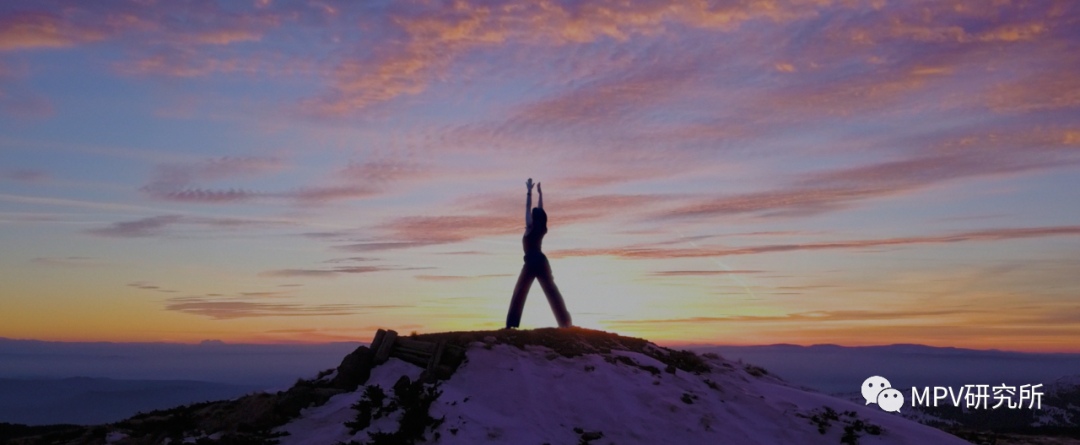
0,0,1080,352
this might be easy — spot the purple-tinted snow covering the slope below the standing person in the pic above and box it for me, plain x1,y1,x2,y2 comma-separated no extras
275,334,967,445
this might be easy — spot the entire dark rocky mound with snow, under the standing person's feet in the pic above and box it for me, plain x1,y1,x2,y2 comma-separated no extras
9,328,967,445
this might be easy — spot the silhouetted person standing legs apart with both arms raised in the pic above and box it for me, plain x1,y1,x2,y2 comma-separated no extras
507,178,571,327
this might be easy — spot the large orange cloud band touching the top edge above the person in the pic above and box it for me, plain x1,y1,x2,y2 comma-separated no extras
305,0,842,116
